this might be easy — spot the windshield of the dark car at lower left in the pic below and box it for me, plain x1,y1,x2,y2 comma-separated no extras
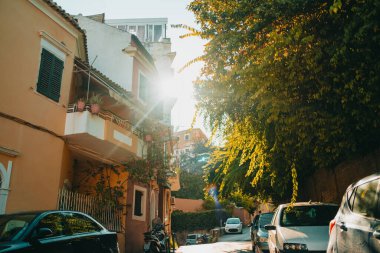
0,214,36,242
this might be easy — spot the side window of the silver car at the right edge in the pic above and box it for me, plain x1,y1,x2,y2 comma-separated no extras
352,180,379,217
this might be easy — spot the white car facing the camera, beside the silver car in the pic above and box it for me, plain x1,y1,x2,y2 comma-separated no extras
265,202,338,253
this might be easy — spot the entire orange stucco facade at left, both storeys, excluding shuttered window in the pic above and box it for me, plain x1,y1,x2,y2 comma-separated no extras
0,0,81,213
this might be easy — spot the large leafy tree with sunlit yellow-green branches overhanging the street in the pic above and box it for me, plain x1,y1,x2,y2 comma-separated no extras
189,0,380,201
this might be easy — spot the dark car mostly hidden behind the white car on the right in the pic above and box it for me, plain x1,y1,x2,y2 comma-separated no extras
250,213,274,252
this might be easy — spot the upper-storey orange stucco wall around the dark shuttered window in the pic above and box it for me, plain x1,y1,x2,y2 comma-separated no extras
0,0,79,136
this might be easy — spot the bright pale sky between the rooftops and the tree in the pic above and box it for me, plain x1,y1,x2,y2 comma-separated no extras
54,0,209,136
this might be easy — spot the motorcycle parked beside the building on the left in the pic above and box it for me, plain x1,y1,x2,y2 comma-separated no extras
144,224,167,253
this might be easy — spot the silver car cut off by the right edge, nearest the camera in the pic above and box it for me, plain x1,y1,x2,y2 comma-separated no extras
327,173,380,252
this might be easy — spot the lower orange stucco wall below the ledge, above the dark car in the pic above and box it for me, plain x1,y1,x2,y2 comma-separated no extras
0,117,64,213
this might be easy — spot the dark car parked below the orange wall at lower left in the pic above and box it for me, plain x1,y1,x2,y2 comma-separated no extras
0,211,119,253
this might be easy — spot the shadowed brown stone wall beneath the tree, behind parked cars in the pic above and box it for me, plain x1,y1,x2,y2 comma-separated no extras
299,150,380,204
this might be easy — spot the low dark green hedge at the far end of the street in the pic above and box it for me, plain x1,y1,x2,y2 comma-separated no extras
172,209,231,232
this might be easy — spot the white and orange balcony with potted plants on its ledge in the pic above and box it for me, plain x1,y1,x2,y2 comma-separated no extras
65,105,146,162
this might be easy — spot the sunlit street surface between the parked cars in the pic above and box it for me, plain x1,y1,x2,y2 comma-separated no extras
176,228,252,253
